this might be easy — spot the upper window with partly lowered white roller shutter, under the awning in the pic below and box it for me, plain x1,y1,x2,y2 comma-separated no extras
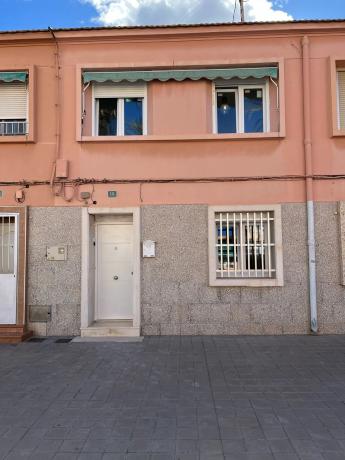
92,82,147,136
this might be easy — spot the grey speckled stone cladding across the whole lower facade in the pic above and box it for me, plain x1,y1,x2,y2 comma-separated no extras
26,203,345,335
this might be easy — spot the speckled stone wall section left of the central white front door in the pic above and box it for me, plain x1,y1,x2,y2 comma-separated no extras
27,207,81,335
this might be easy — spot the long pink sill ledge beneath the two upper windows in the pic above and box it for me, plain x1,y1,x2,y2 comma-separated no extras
78,132,285,142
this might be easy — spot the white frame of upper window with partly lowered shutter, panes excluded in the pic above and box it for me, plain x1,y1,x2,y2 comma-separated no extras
91,83,147,138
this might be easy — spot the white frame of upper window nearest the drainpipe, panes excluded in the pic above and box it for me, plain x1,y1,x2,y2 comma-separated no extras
212,80,270,134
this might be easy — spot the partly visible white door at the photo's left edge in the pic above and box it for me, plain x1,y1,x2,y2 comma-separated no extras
0,213,18,324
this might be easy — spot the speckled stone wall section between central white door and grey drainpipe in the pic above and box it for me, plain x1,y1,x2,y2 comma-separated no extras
142,204,309,335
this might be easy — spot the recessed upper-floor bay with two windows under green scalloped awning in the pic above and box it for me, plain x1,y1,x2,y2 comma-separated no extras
77,65,278,141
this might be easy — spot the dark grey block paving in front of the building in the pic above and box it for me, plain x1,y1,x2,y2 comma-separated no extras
0,336,345,460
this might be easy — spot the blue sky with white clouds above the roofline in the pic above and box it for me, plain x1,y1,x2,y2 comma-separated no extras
0,0,345,30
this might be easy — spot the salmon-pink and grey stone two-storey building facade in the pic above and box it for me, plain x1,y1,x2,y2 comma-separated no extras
0,21,345,341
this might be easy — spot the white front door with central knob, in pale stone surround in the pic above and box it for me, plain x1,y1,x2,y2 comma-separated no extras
95,223,133,320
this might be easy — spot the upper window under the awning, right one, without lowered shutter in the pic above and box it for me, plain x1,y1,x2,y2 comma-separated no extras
214,82,270,134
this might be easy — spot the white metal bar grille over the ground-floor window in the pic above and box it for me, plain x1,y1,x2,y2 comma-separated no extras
215,211,276,279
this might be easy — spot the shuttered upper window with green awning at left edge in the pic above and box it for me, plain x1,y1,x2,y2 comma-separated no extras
0,72,29,136
